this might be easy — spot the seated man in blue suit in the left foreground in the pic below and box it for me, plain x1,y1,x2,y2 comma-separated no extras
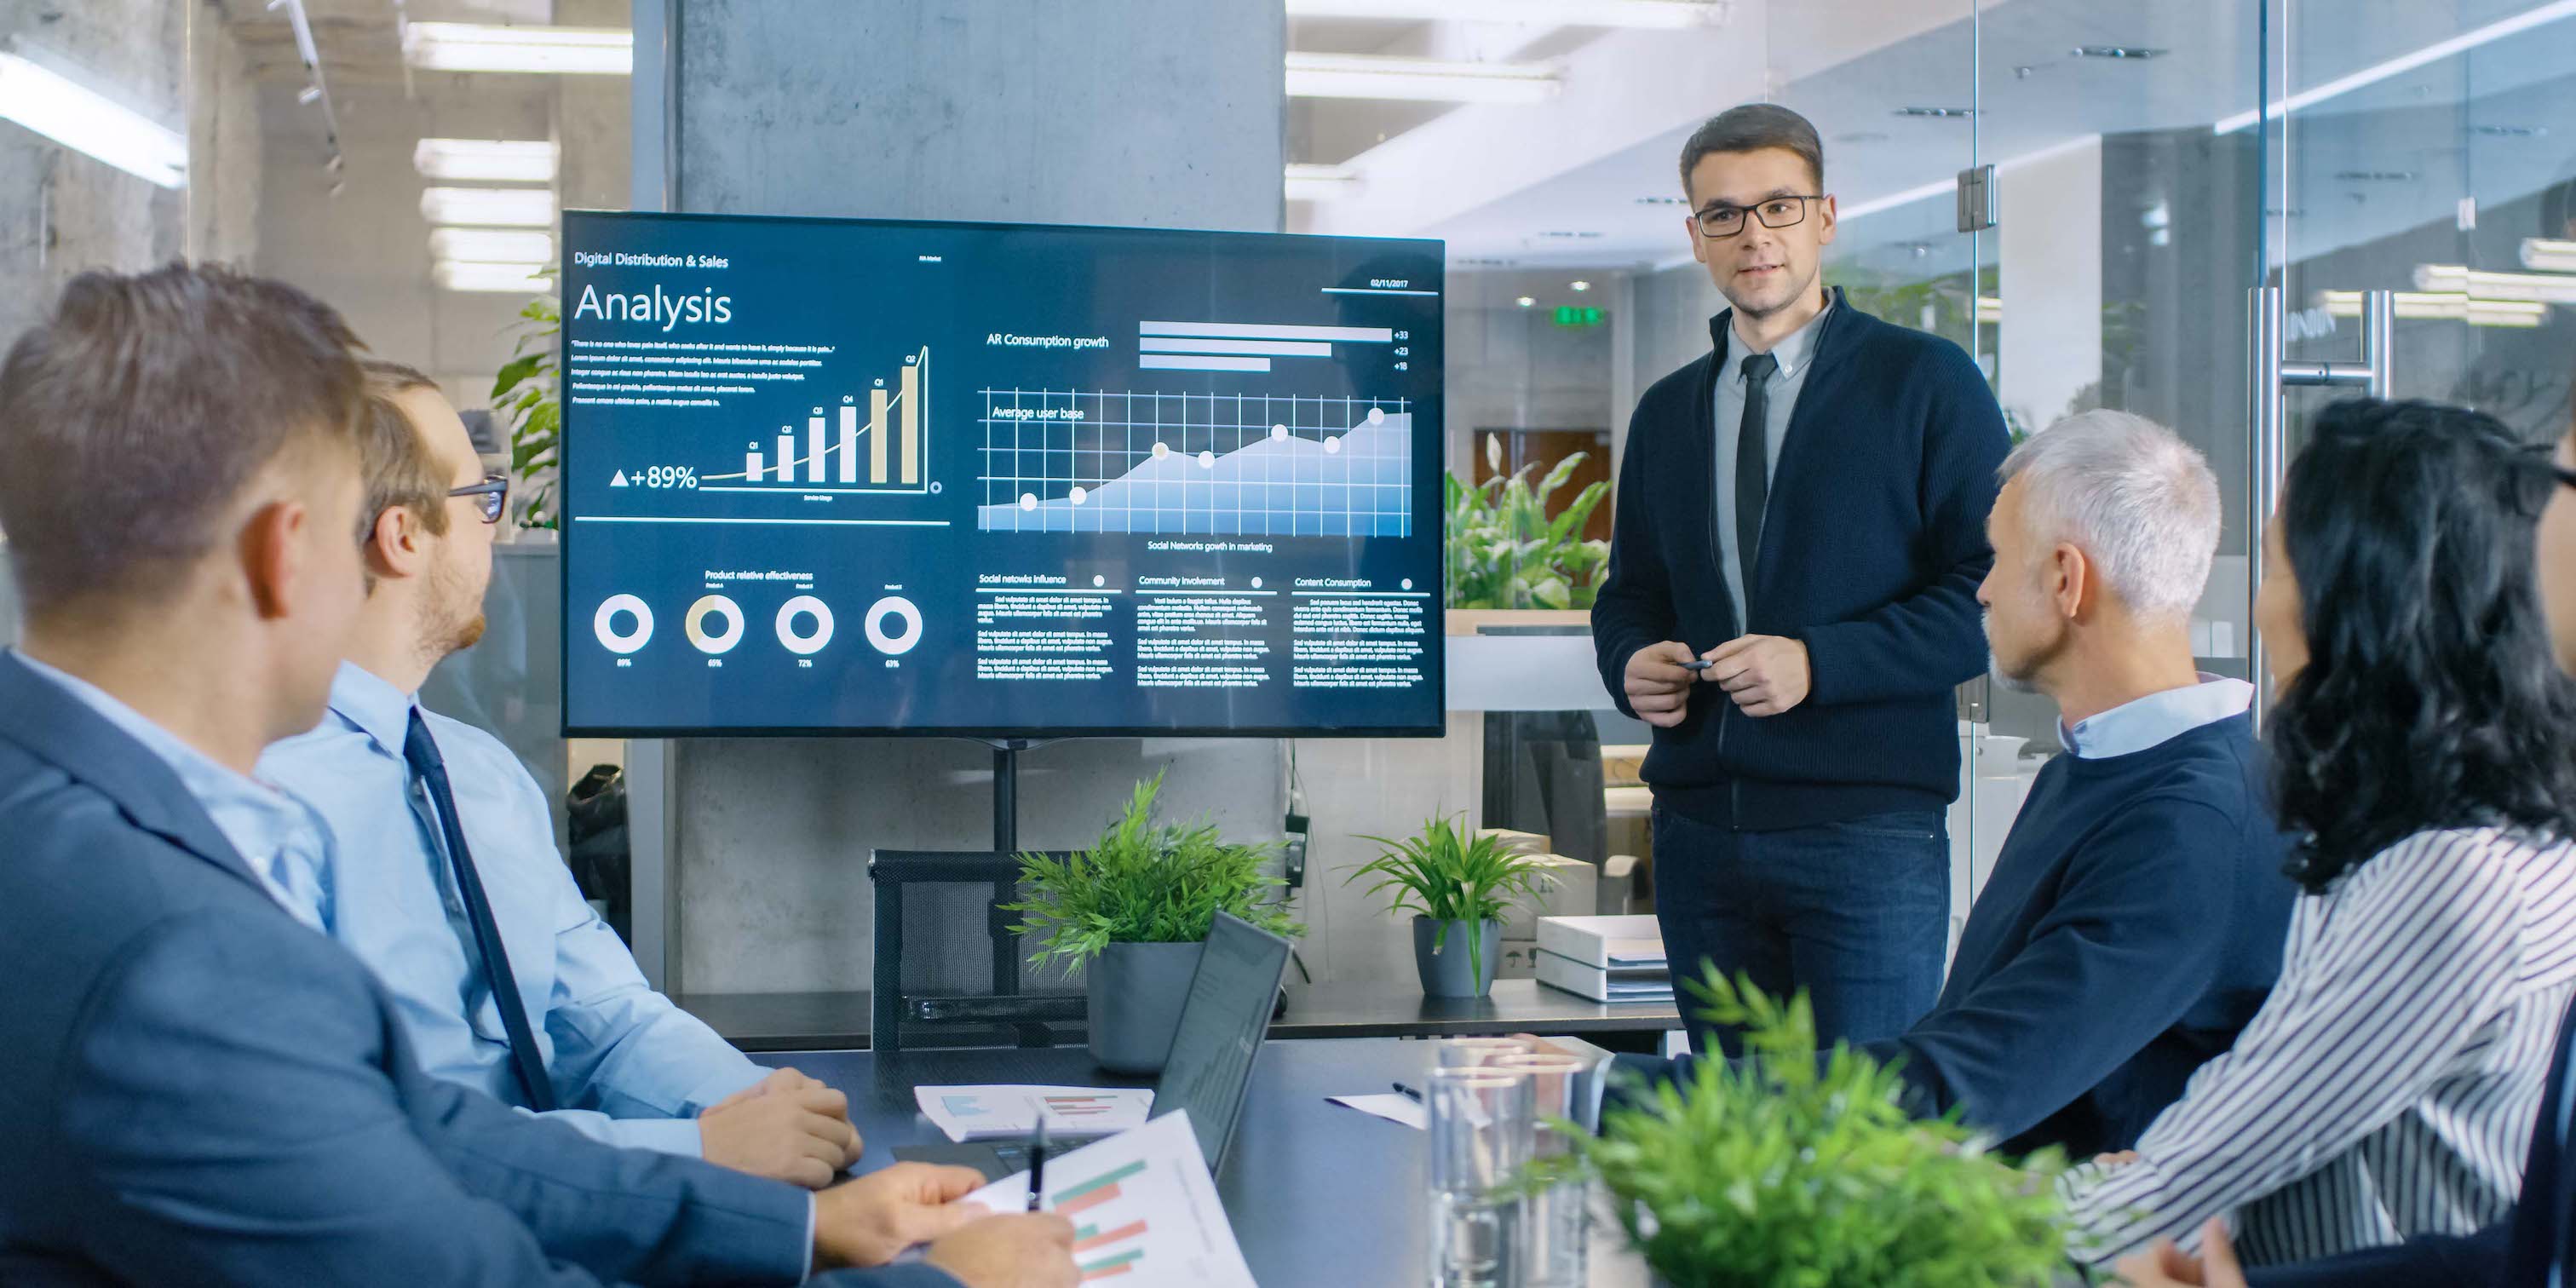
0,265,1074,1288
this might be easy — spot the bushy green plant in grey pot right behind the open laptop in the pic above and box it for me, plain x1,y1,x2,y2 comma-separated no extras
1002,773,1303,1074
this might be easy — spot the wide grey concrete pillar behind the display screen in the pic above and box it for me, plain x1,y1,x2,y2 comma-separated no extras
670,0,1285,992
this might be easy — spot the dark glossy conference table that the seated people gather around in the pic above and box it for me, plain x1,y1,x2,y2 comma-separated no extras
752,1038,1648,1288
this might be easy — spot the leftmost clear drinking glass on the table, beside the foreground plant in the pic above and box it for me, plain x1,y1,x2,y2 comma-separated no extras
1424,1067,1532,1288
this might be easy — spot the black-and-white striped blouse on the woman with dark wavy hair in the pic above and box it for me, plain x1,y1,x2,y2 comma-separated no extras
2061,830,2576,1265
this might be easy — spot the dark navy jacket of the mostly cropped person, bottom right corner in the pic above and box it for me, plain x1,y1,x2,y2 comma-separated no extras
2246,1007,2576,1288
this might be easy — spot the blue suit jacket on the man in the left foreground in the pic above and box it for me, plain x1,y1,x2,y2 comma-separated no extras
0,652,953,1288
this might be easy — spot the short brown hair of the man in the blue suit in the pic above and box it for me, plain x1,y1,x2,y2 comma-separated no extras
0,262,358,613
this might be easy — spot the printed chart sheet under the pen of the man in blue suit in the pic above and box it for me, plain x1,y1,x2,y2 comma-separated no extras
966,1110,1255,1288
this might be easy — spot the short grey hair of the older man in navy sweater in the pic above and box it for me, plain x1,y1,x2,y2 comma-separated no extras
1997,410,2218,621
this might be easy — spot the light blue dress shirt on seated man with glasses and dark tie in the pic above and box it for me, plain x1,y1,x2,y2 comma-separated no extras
260,664,768,1154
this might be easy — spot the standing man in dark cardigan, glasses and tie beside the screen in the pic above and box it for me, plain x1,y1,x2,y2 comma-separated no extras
1592,103,2010,1054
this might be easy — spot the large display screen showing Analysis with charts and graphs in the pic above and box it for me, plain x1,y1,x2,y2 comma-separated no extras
561,211,1442,737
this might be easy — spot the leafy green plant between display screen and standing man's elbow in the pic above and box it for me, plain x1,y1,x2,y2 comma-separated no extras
1442,435,1610,608
